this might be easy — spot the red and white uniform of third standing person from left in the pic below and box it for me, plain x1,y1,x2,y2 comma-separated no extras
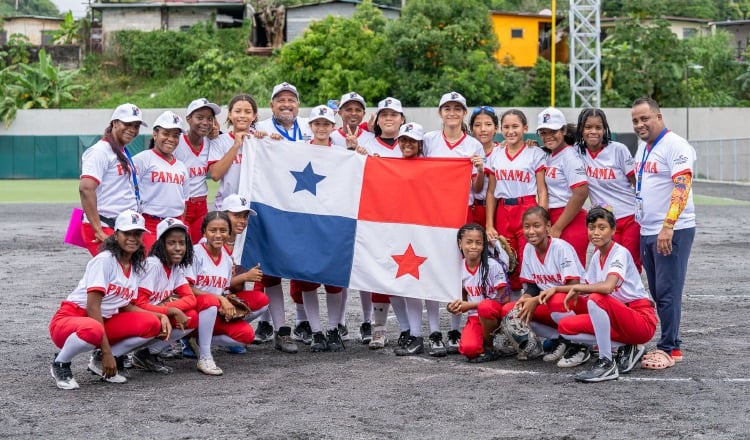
174,134,209,243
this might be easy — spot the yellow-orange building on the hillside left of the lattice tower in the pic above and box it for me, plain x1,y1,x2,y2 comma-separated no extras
490,11,568,67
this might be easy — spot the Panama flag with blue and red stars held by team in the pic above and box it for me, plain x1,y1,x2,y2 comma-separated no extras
240,139,472,301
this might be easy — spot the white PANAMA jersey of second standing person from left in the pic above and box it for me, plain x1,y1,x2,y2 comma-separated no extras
133,148,188,217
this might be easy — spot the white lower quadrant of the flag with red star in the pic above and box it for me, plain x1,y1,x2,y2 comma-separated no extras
349,220,461,301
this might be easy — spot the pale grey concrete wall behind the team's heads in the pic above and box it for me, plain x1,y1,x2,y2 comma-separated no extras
0,106,750,142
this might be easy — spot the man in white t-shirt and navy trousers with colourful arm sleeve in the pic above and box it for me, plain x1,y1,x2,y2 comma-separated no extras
631,97,695,368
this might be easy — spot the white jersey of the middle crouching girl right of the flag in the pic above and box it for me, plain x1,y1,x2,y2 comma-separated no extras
520,237,584,290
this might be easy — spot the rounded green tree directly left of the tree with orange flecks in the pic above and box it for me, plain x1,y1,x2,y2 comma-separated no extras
278,0,389,106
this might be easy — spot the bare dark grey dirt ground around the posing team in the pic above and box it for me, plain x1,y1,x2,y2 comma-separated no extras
0,180,750,439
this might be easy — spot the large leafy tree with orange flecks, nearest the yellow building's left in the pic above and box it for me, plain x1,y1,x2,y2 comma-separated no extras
388,0,507,106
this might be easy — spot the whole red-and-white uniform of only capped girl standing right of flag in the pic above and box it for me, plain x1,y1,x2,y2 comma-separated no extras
545,145,589,264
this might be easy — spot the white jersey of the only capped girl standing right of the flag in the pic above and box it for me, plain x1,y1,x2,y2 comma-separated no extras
545,145,587,208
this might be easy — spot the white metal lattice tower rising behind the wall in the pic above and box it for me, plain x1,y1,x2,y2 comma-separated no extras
568,0,602,108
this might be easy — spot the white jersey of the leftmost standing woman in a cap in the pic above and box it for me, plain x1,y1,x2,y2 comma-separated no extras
81,139,138,222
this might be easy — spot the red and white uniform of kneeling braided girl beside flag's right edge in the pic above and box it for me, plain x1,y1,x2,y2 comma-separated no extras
458,258,507,359
